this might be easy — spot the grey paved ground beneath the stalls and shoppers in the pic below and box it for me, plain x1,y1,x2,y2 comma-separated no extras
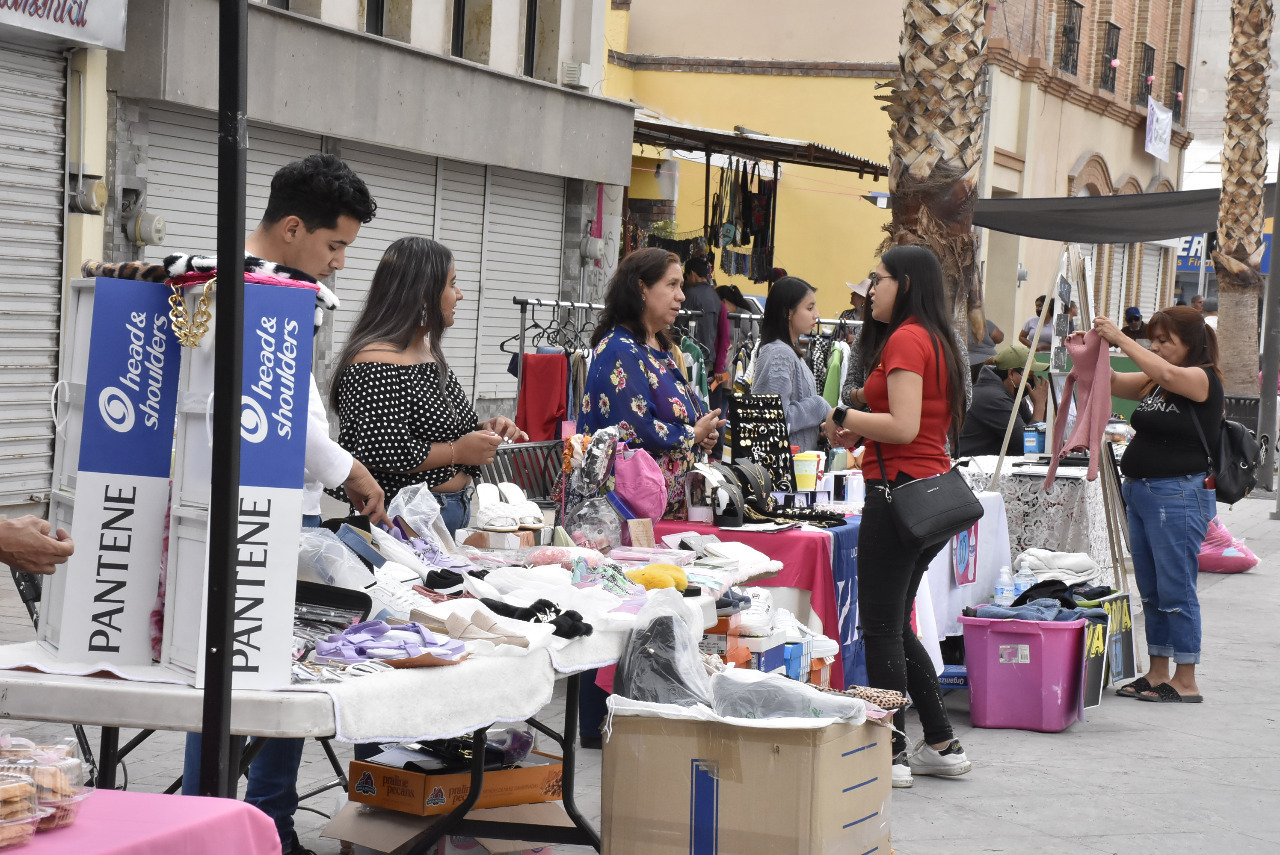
0,491,1280,855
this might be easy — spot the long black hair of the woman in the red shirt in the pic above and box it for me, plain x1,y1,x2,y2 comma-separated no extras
864,244,969,435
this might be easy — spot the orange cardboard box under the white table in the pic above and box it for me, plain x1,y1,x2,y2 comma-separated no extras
347,755,564,817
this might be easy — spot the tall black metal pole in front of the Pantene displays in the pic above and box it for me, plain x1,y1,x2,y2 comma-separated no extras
200,0,248,797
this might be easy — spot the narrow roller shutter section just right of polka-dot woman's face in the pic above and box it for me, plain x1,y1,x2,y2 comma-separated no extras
435,160,483,393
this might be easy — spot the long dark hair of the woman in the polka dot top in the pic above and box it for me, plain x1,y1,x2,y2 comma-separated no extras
329,231,453,410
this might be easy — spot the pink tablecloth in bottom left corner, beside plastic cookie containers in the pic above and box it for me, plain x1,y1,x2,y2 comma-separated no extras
22,790,280,855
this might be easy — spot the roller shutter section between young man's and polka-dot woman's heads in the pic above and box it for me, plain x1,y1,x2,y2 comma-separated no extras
333,143,437,363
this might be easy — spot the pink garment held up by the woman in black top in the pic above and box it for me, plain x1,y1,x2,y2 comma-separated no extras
1044,329,1111,490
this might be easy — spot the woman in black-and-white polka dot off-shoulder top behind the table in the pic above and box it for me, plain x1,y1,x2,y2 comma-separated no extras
330,238,527,534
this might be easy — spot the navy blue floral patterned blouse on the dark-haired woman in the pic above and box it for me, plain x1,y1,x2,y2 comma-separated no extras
577,326,705,517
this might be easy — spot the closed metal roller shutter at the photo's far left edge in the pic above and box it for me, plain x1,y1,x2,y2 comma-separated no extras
0,42,67,507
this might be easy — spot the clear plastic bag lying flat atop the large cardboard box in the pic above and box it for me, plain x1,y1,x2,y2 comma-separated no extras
710,668,867,724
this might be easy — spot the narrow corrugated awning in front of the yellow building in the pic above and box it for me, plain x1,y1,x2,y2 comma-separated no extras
635,115,888,180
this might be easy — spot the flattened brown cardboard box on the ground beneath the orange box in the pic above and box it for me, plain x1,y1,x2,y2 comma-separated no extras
320,803,573,855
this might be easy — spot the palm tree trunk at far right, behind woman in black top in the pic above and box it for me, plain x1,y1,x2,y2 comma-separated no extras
1213,0,1274,394
